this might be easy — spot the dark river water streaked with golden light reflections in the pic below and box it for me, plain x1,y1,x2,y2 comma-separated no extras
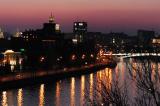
0,60,160,106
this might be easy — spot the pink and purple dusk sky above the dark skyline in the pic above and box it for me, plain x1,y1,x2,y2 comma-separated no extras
0,0,160,34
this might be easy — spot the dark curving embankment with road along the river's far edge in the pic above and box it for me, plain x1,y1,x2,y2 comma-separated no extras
0,63,115,90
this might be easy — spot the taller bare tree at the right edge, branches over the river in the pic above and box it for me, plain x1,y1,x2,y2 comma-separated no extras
128,60,160,106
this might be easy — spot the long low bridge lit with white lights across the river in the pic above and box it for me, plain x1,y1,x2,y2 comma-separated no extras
103,53,160,58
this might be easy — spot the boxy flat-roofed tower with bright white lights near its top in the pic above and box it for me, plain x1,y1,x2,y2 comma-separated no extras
73,22,87,42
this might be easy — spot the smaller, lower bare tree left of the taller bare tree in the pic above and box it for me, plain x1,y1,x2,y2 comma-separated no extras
86,71,129,106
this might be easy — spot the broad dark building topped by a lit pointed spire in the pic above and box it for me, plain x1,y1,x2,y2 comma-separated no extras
23,14,61,41
